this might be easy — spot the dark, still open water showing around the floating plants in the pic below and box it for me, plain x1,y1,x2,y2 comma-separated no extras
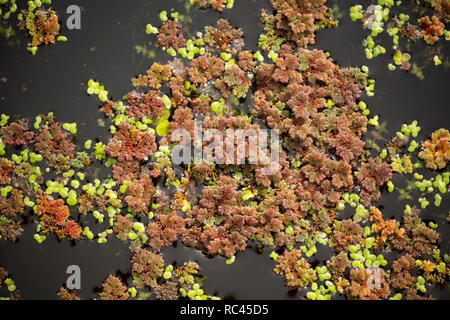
0,0,450,299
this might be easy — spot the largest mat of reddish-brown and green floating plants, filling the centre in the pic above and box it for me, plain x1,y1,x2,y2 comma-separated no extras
0,0,450,300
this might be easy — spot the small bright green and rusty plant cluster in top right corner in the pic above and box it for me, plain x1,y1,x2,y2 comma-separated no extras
350,0,450,74
